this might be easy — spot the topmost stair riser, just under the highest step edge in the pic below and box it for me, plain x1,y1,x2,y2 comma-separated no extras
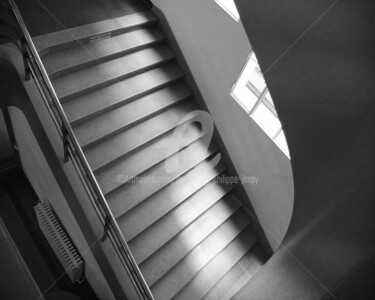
39,20,158,57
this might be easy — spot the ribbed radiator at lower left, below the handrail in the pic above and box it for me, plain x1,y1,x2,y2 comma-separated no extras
35,200,83,283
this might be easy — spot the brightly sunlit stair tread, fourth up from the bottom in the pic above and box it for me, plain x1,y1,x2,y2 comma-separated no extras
140,203,249,286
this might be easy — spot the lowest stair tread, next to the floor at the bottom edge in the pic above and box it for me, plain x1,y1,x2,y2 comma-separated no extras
203,243,266,300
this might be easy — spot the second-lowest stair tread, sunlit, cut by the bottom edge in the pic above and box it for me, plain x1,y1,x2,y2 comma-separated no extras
175,226,257,300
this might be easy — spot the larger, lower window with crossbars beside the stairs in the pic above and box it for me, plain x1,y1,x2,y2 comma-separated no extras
231,51,289,157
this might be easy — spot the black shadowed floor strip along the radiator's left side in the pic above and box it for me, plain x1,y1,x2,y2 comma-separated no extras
0,167,97,300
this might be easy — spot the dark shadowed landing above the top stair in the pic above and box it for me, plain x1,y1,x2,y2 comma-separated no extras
16,0,148,36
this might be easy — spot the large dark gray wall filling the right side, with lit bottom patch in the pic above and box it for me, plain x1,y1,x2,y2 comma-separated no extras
235,0,375,300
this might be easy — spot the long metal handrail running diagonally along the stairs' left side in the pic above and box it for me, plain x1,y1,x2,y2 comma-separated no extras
4,0,154,299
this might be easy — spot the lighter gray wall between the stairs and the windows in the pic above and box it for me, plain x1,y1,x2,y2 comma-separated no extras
153,0,294,250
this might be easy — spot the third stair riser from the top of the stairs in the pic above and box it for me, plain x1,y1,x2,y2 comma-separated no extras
59,57,174,103
